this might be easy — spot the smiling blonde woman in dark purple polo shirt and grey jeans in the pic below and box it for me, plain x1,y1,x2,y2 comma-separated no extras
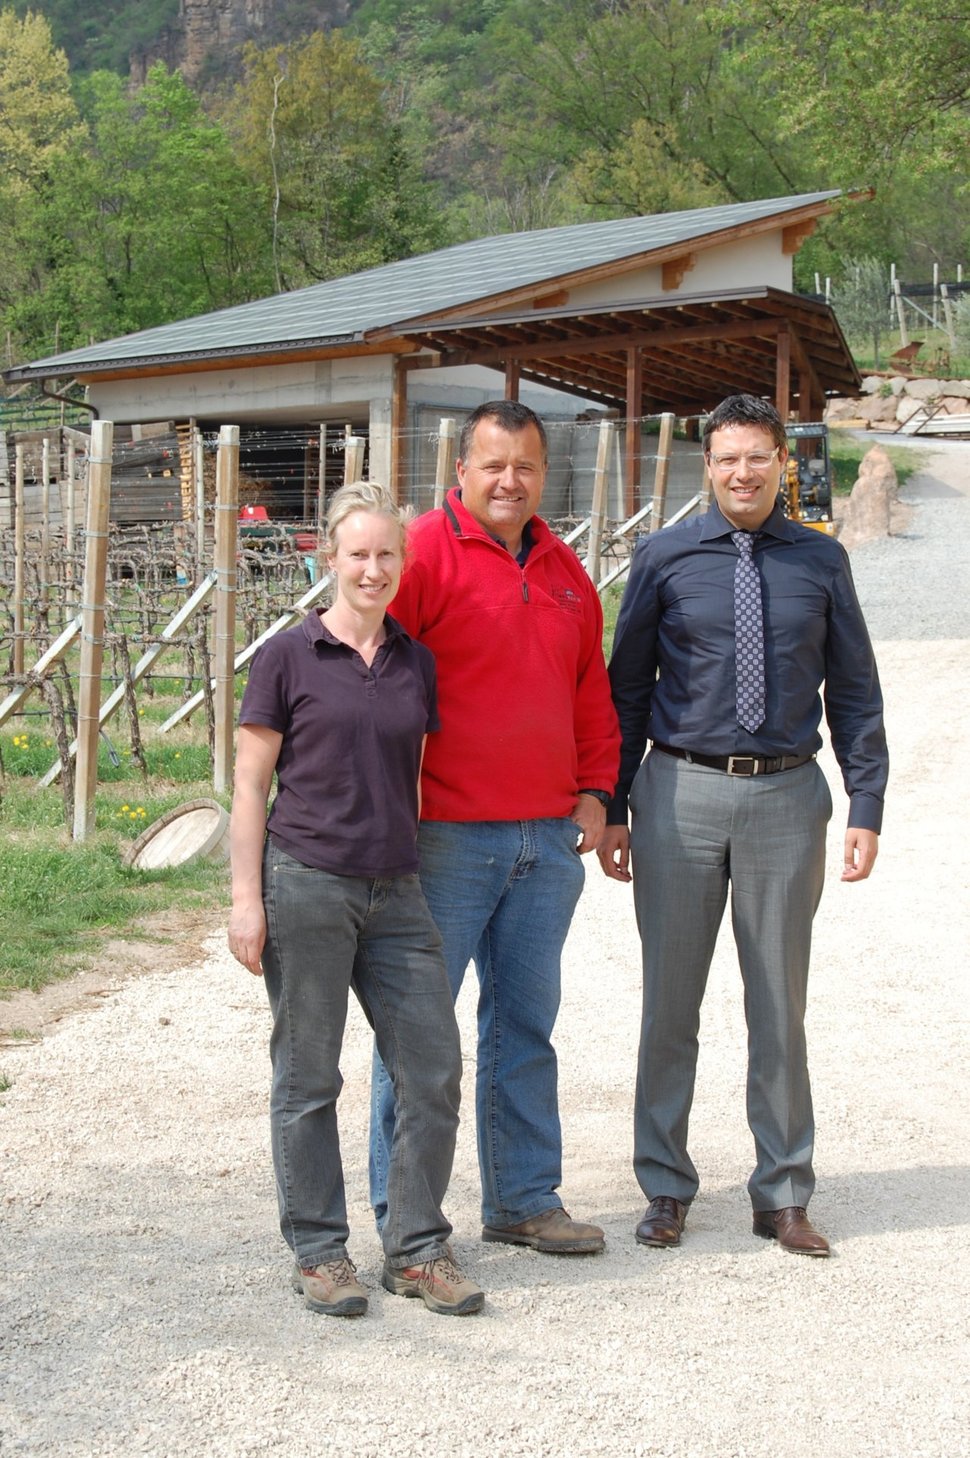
229,481,484,1317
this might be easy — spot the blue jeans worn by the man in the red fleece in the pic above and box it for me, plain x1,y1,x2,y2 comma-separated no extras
370,819,583,1228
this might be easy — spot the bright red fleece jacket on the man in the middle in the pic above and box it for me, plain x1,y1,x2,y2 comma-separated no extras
391,488,620,821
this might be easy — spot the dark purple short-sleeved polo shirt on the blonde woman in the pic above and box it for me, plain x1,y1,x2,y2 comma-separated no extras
239,612,439,878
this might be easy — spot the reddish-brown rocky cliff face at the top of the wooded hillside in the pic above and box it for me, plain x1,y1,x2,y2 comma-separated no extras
130,0,350,85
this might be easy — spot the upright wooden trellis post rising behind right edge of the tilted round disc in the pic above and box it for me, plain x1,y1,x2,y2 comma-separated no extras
213,426,239,795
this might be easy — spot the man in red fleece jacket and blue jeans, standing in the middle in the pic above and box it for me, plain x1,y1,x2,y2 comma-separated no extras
370,399,618,1254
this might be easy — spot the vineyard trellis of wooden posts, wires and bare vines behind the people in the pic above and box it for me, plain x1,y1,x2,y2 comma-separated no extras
0,417,706,840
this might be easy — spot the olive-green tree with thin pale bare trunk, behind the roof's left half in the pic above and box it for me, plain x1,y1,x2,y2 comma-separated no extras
226,32,442,289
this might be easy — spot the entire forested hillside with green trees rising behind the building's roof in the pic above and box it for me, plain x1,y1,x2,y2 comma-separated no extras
0,0,970,376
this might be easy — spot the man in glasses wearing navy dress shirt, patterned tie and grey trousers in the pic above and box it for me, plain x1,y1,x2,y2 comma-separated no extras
598,395,888,1255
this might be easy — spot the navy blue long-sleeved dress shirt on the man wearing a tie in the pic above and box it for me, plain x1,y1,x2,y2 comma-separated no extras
607,504,888,831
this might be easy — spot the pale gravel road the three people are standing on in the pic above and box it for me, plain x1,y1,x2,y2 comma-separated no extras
0,443,970,1458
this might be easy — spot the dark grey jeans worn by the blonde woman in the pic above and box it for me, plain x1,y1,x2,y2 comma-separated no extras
263,840,461,1267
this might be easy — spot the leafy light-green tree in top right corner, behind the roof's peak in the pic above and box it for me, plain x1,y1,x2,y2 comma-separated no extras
723,0,970,276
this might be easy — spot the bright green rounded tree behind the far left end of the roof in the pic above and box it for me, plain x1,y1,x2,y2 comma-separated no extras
4,64,271,354
